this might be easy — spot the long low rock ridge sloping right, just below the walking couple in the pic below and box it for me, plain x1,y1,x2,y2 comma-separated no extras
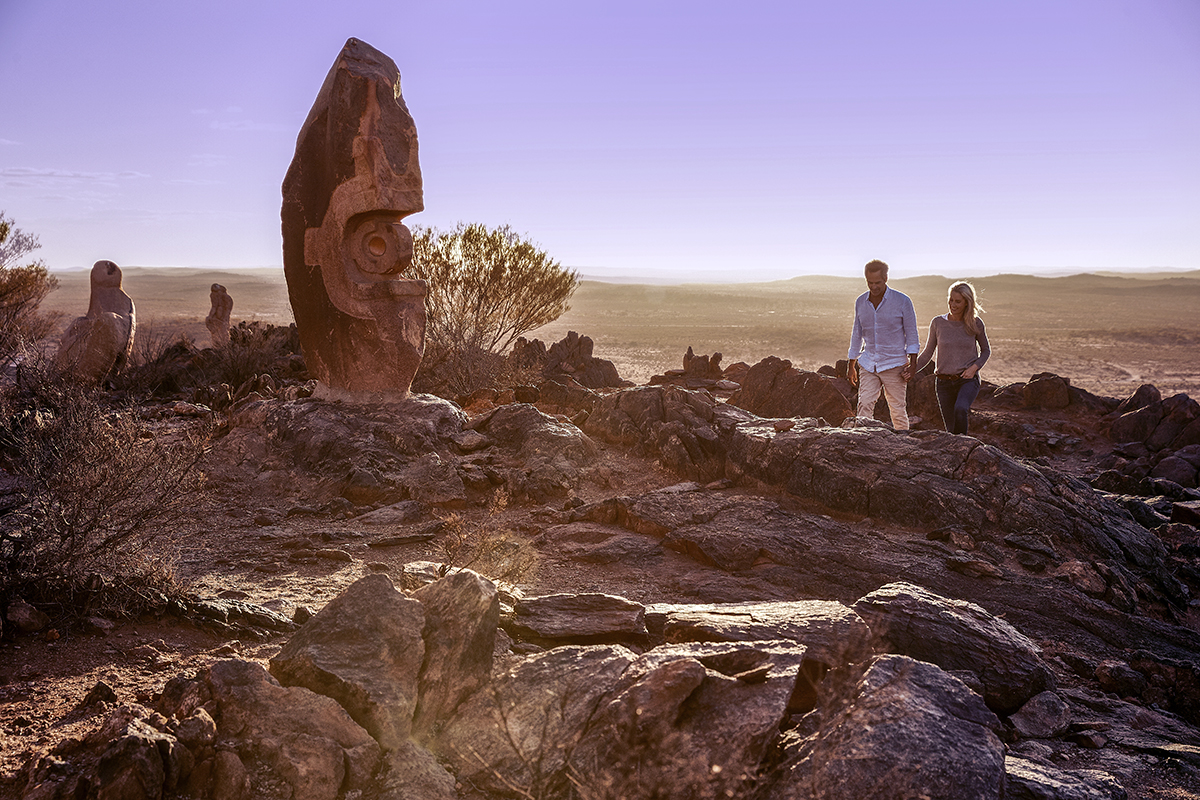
584,387,1165,575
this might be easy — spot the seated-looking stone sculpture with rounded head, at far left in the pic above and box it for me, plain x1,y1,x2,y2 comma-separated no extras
54,261,137,383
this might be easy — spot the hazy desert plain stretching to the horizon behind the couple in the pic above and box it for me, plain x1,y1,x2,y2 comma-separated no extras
37,266,1200,397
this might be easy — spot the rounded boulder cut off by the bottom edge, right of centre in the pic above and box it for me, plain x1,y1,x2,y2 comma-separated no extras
758,655,1004,800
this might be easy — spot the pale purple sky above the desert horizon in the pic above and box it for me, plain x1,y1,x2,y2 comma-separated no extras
0,0,1200,281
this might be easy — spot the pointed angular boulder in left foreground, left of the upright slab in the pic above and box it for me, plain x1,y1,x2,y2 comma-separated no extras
271,573,425,750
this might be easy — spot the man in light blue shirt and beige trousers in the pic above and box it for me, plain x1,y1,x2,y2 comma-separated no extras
847,260,920,431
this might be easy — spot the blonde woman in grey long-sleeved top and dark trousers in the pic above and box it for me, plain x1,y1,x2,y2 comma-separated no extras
917,281,991,433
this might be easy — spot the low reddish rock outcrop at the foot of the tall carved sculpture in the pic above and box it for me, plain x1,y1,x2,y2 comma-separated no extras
216,395,596,511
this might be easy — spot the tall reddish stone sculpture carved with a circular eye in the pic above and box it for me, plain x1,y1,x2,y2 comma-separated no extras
282,38,427,399
